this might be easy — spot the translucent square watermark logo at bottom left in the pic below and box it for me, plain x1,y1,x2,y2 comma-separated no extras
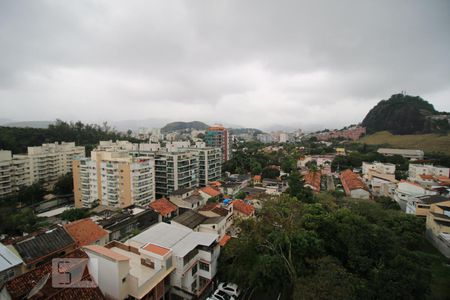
52,258,98,288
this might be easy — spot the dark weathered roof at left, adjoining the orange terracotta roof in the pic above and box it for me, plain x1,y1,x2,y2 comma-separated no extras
7,226,77,272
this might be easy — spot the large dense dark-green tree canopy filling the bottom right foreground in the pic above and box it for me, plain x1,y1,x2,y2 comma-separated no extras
220,195,431,299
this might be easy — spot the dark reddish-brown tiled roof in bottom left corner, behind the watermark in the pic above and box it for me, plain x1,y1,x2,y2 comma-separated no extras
5,249,105,300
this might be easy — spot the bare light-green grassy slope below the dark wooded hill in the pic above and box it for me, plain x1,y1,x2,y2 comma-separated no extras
358,131,450,155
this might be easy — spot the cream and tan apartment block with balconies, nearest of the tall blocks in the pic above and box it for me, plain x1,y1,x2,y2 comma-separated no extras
73,150,155,208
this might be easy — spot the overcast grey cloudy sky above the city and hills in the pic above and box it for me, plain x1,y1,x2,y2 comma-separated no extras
0,0,450,128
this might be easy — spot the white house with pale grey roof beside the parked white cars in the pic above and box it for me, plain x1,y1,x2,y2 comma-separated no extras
126,223,220,299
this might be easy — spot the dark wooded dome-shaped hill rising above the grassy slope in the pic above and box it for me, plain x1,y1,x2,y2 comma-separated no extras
362,94,450,134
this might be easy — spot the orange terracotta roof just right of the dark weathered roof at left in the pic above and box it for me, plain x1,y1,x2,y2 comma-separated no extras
64,218,109,247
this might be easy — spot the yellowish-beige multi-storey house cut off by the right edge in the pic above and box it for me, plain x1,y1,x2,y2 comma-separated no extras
426,201,450,258
